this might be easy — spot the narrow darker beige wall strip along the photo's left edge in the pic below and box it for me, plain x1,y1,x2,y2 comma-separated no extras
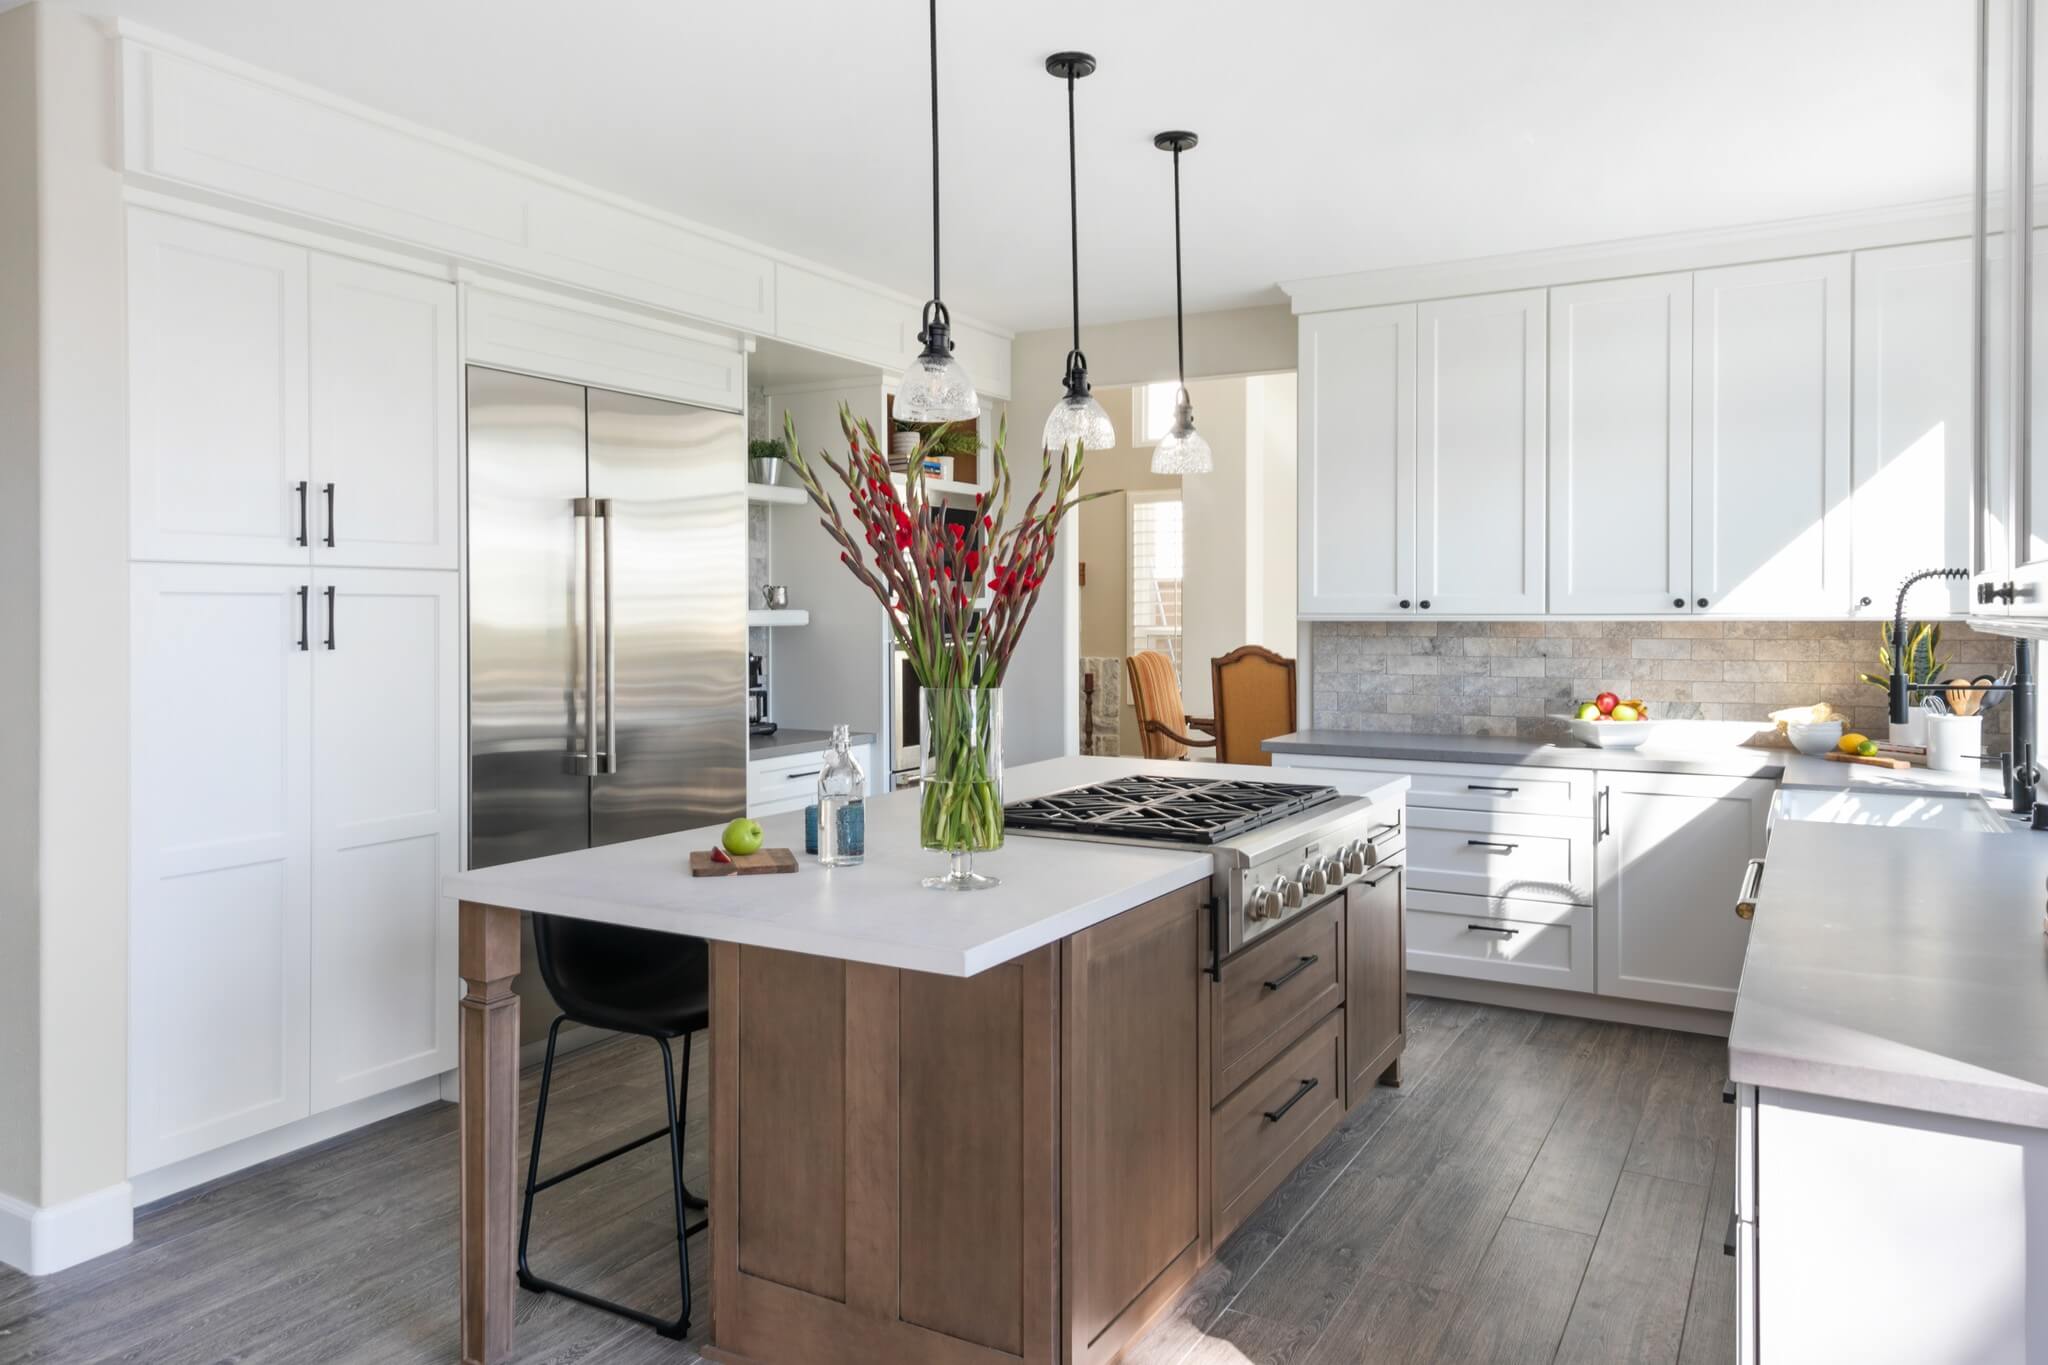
0,8,41,1203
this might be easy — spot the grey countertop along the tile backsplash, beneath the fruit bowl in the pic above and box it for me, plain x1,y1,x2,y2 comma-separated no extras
1264,720,1999,794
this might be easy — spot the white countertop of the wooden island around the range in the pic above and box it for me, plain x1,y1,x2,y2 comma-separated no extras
442,757,1407,976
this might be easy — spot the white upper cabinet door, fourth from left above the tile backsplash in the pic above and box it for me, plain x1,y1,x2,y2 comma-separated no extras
1692,256,1849,616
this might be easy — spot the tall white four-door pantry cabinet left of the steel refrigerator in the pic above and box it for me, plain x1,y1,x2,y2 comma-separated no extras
129,209,463,1175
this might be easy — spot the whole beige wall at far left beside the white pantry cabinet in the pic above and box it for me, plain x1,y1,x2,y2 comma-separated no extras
0,6,129,1207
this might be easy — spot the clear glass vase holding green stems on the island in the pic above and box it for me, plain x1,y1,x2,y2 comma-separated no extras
918,688,1004,890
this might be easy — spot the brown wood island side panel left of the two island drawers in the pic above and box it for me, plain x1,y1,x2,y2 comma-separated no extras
1061,886,1210,1365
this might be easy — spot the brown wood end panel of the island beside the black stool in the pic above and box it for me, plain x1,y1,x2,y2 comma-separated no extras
711,943,1061,1365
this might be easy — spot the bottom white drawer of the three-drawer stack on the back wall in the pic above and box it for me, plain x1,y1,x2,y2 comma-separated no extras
1407,884,1595,990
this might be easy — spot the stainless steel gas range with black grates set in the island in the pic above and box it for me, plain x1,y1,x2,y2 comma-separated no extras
1004,776,1403,956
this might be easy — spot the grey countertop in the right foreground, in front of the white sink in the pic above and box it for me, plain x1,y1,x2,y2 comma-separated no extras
1729,825,2048,1128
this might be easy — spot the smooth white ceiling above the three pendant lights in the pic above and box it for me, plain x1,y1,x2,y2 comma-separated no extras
56,0,1974,327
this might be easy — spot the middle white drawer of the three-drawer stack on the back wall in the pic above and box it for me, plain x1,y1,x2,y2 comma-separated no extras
1407,806,1593,905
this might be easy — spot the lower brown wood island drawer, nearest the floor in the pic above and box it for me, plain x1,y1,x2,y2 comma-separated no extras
1210,1009,1343,1244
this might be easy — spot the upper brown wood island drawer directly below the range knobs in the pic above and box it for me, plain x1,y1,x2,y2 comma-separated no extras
1210,894,1343,1097
